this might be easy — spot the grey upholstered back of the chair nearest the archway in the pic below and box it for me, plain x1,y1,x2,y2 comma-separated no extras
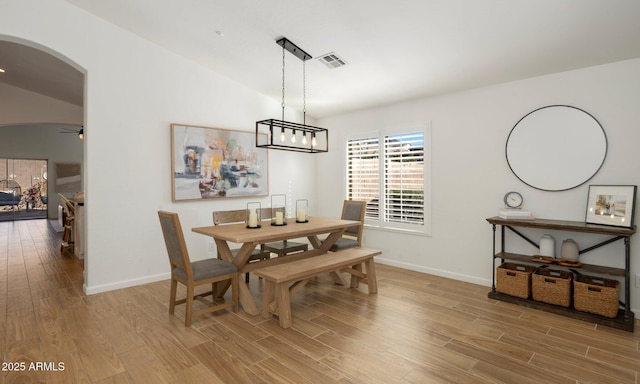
158,211,193,280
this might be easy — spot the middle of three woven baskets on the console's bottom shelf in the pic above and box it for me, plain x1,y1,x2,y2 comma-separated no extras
531,268,573,307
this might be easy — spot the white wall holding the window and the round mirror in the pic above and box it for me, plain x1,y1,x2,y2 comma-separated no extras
318,59,640,314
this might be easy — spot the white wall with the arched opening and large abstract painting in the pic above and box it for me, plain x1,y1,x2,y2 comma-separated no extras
0,0,317,293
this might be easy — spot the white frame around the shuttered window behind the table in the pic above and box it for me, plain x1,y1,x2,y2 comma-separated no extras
344,124,431,236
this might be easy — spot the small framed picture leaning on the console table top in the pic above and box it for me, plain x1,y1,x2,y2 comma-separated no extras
585,185,637,228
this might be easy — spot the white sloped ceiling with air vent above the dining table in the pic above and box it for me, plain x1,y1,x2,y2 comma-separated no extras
0,0,640,118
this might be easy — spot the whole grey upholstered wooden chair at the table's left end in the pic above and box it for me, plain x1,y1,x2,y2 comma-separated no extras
158,211,239,327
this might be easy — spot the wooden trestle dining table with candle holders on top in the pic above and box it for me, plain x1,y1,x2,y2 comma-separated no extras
191,216,360,316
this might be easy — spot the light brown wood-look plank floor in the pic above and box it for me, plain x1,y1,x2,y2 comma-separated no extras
0,220,640,384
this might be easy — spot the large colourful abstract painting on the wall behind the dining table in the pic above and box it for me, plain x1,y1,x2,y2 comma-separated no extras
171,124,269,201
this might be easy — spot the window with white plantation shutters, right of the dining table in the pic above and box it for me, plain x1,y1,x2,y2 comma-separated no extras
347,131,430,233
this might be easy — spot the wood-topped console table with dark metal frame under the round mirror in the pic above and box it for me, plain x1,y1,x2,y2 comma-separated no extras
487,217,636,332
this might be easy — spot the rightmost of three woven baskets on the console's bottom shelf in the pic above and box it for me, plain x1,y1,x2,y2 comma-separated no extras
573,275,620,317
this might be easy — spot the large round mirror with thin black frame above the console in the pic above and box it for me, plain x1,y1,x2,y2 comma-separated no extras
506,105,607,191
